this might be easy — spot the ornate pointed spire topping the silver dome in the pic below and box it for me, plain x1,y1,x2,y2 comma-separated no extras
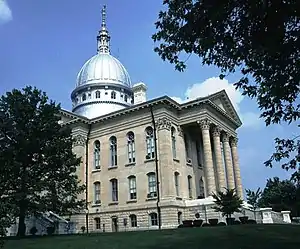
97,5,110,54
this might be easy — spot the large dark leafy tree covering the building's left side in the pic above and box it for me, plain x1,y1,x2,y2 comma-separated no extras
0,87,84,236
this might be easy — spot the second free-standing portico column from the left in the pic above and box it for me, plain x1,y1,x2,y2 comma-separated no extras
213,126,226,191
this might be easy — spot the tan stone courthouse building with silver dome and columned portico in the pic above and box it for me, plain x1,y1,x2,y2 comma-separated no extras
61,7,243,232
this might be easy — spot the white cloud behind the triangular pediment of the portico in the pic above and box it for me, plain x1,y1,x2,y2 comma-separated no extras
172,77,261,128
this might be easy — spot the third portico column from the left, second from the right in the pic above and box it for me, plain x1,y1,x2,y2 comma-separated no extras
222,132,235,189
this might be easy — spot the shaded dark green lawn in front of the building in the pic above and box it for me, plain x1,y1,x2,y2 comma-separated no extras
4,225,300,249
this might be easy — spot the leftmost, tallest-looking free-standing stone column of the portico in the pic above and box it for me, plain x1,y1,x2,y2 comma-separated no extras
199,119,216,195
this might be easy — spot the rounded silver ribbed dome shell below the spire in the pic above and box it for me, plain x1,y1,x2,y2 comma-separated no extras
76,53,131,88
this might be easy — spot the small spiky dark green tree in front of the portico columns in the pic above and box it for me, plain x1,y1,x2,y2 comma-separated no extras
213,188,243,218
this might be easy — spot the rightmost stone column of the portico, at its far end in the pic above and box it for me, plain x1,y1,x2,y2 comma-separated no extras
230,137,243,198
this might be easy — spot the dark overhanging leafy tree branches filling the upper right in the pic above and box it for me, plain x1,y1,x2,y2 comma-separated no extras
152,0,300,178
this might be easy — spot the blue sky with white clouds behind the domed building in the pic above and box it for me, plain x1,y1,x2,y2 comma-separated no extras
0,0,296,193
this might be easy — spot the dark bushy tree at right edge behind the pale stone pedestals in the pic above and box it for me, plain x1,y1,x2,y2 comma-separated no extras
258,177,300,216
